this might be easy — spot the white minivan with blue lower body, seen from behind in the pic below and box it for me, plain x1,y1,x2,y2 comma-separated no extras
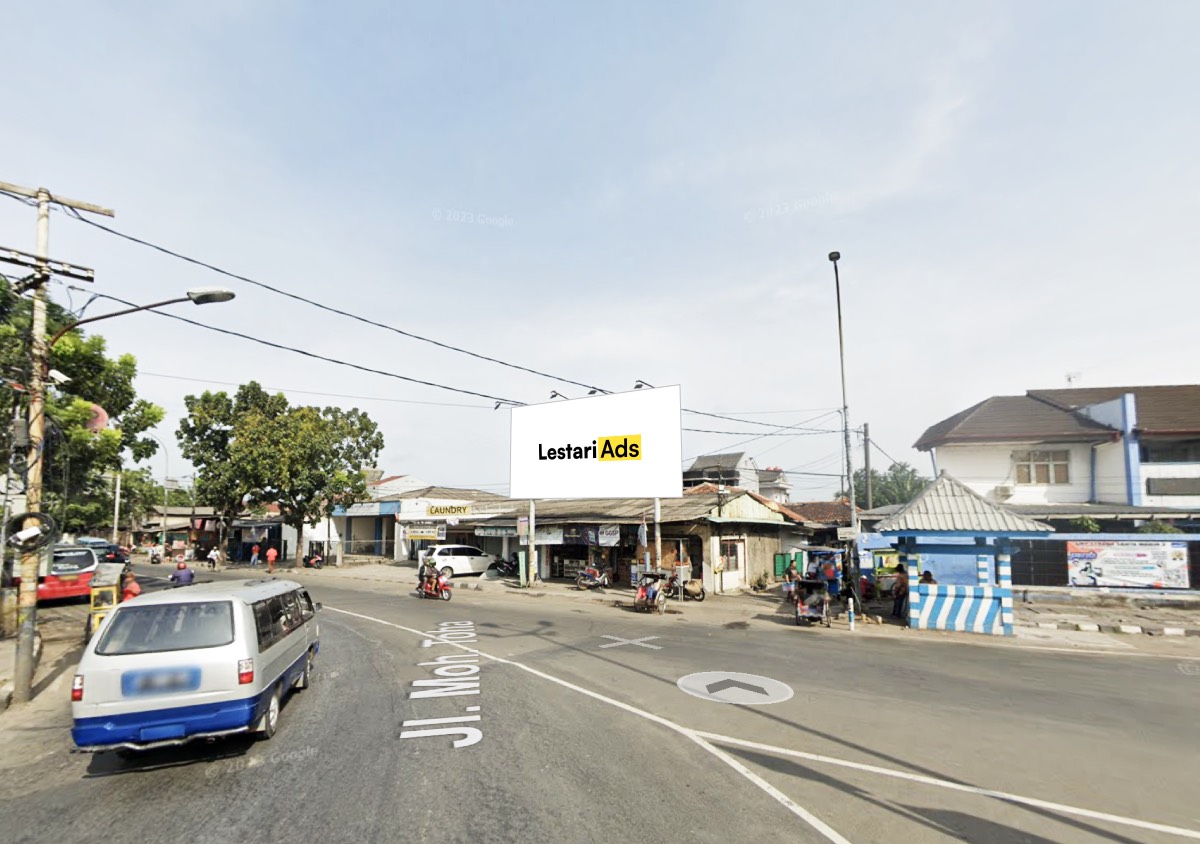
71,577,320,750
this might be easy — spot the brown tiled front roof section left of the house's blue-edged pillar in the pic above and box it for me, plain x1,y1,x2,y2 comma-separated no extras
913,395,1117,451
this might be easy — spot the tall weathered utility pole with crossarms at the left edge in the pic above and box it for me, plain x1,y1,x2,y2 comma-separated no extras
0,181,115,704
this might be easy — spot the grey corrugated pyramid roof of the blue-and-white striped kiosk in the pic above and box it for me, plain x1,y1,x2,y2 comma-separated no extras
875,469,1054,533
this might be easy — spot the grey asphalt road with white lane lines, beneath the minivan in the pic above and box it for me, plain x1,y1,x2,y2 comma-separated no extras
0,566,1200,844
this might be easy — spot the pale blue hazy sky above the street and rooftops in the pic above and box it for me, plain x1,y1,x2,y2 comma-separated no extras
0,0,1200,501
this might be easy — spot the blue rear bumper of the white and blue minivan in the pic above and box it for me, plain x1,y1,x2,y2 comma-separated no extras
71,694,263,750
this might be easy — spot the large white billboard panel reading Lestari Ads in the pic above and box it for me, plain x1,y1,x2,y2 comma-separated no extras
509,387,683,498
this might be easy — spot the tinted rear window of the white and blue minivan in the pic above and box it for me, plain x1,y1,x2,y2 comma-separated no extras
96,600,233,657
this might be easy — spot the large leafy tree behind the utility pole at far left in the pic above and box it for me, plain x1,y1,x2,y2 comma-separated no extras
0,276,163,532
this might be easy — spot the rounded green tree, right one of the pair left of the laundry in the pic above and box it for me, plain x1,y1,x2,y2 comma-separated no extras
229,407,383,564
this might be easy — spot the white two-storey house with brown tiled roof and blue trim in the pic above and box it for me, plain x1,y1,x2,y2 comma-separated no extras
914,385,1200,509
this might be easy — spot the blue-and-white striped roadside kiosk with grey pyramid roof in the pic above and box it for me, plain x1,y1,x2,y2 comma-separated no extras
875,472,1054,636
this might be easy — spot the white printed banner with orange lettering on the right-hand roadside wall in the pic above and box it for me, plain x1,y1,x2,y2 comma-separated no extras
1067,539,1188,589
